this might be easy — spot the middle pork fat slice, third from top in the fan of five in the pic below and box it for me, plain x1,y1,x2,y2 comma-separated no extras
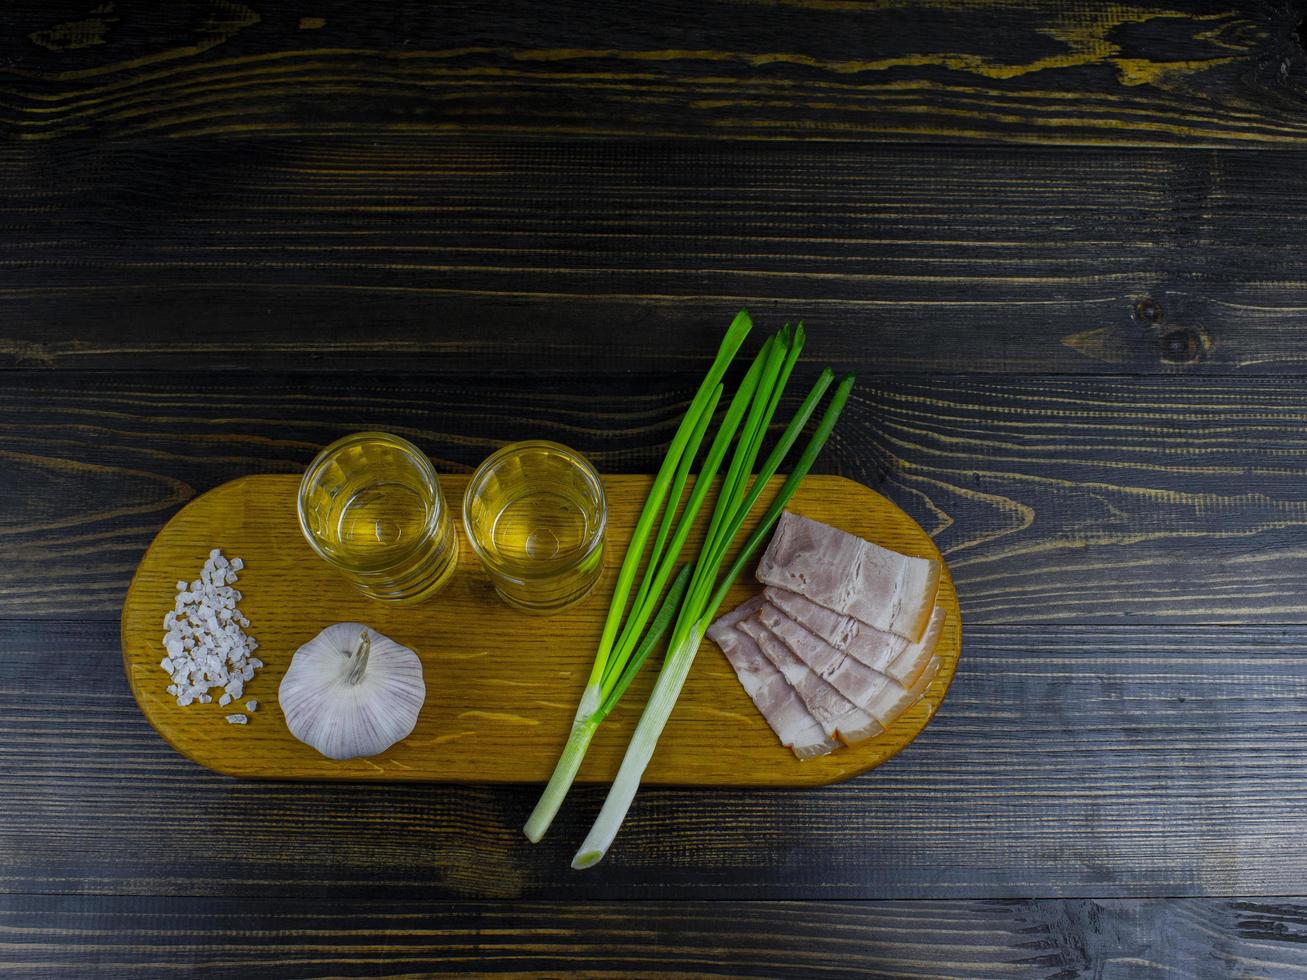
758,604,940,728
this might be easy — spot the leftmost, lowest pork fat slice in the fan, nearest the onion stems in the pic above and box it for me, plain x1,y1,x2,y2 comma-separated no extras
708,596,838,759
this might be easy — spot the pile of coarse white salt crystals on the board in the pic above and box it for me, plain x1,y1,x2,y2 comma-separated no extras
159,547,263,724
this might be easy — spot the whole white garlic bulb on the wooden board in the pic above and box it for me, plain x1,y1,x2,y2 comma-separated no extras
277,623,426,759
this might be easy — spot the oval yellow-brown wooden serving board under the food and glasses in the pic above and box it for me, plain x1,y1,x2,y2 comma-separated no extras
122,476,962,787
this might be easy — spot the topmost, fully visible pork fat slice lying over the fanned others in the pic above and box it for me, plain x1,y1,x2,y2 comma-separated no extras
758,511,940,643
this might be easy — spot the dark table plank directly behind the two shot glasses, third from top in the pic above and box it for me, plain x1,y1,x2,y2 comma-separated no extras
10,371,1307,625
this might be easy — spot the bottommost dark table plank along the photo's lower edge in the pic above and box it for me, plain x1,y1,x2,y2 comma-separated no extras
0,895,1307,980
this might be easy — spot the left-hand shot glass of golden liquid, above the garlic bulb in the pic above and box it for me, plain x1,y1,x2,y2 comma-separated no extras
299,433,459,602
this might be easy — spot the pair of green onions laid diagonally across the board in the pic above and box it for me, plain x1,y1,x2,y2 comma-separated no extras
524,311,852,868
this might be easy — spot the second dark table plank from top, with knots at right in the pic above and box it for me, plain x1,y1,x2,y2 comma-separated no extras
0,137,1307,375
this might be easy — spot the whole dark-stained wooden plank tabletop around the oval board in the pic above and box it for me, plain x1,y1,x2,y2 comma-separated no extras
0,0,1307,977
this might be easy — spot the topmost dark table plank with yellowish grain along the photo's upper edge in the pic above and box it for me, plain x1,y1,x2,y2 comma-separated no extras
0,0,1307,146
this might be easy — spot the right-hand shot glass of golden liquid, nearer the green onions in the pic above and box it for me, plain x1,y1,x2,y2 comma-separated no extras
463,440,608,615
